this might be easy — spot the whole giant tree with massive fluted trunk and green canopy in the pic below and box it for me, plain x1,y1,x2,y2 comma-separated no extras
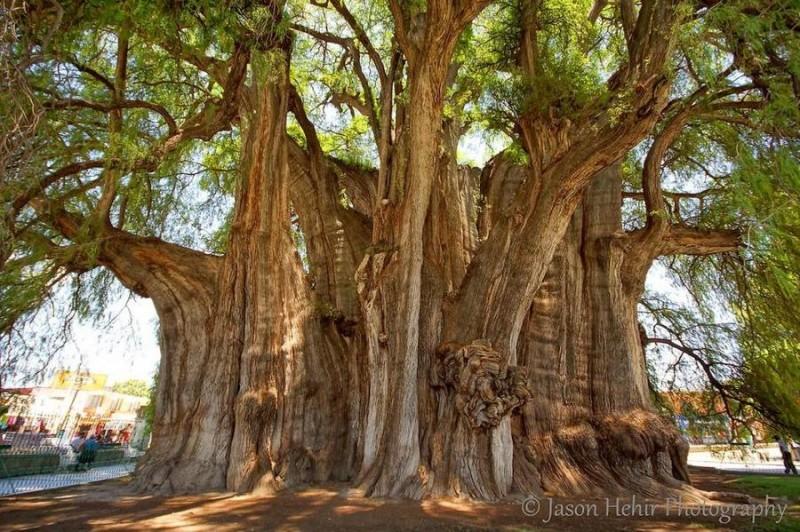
0,0,800,500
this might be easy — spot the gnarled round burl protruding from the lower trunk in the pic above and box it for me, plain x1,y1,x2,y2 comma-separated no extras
434,340,532,429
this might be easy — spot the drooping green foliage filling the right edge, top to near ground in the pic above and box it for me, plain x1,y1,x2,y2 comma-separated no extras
626,1,800,433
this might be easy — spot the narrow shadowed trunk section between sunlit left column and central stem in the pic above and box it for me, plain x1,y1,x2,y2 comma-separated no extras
289,98,371,478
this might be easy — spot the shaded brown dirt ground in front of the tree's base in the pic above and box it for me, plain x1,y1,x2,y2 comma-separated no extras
0,470,800,532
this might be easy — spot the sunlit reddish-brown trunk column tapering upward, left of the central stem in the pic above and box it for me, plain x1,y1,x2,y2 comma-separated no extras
214,47,347,491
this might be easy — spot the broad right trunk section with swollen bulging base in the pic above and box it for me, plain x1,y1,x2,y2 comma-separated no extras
514,167,689,495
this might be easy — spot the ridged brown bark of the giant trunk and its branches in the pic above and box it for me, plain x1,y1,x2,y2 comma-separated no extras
17,0,756,508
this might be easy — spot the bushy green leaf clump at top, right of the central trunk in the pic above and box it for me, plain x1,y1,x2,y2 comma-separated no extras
463,0,617,127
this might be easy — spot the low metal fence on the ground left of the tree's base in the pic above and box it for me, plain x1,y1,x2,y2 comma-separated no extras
0,442,143,496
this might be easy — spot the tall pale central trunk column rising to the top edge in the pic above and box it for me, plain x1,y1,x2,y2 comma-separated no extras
357,4,486,497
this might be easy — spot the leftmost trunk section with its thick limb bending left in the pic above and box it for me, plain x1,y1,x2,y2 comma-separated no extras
100,233,228,492
